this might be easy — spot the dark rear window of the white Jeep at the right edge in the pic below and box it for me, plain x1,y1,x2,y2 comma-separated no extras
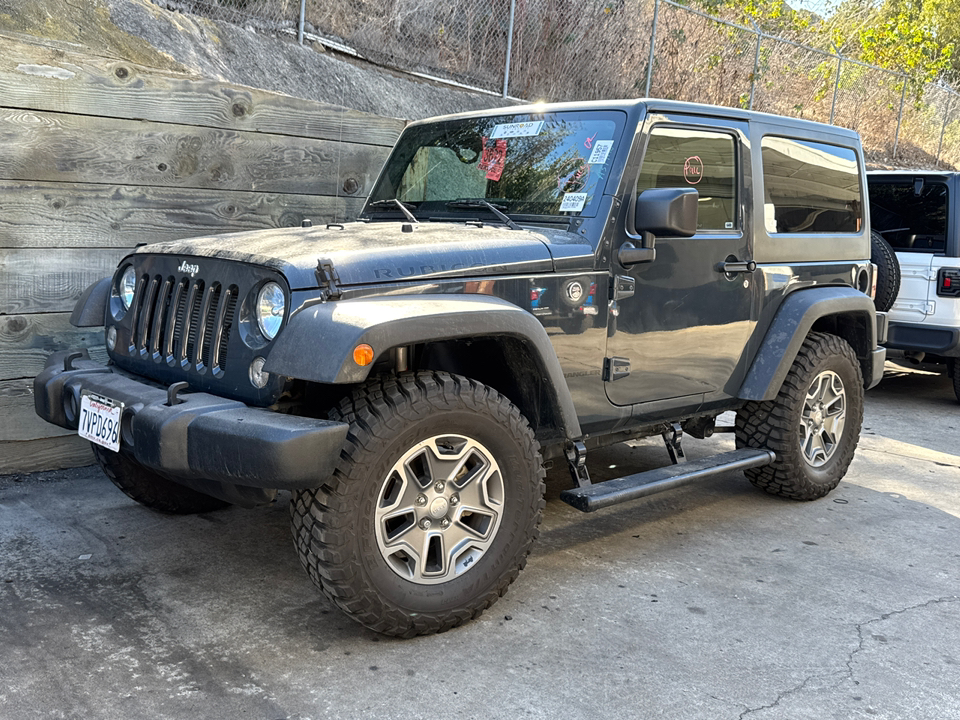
867,179,947,252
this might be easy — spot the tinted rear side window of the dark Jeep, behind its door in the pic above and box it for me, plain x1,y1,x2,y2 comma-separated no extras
760,136,863,234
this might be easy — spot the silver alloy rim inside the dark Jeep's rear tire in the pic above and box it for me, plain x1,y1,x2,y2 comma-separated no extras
800,370,847,467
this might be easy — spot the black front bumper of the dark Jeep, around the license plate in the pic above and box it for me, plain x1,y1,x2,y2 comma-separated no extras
33,351,349,490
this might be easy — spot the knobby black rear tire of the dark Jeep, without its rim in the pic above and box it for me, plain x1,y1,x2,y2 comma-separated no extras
736,332,863,500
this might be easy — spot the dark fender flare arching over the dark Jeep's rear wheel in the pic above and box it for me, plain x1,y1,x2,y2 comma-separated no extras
737,287,882,401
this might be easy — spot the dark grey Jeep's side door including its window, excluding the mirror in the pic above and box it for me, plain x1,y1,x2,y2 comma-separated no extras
606,118,756,405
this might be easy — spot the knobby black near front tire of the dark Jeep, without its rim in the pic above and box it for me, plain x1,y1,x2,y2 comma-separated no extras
290,372,545,637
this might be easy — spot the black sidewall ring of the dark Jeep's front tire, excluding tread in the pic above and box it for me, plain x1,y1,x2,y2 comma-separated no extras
342,410,540,613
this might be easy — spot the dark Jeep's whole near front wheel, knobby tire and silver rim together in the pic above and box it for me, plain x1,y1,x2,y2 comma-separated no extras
290,372,544,637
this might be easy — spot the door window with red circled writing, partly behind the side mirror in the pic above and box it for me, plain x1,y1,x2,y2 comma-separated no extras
637,125,739,231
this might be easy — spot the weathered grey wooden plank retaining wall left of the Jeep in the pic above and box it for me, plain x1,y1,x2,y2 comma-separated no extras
0,34,404,474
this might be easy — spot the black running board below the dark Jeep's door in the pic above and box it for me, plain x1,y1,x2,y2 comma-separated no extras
560,448,777,512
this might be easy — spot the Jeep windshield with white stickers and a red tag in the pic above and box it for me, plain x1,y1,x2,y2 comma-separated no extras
365,110,626,218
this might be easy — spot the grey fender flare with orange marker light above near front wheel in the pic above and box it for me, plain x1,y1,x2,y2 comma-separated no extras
264,295,582,439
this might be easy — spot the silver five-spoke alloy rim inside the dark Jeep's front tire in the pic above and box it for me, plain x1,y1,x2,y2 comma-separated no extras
374,435,504,585
